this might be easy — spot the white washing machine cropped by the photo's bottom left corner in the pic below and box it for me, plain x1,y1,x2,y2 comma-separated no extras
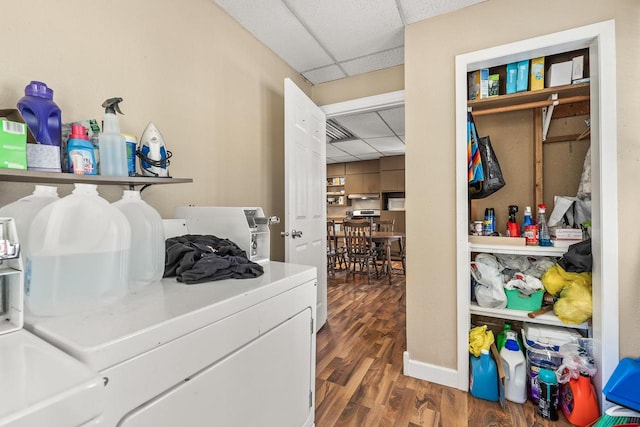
0,329,105,427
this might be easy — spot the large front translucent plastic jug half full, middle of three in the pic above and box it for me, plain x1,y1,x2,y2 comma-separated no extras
25,184,131,316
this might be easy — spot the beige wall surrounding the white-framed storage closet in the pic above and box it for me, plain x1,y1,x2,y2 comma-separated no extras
405,0,640,369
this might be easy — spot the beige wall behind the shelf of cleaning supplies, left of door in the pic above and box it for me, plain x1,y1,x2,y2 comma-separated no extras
0,0,311,259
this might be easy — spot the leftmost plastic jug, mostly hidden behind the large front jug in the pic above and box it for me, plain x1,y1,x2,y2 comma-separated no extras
0,185,60,258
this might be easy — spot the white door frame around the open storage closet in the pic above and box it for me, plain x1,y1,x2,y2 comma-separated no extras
448,20,619,409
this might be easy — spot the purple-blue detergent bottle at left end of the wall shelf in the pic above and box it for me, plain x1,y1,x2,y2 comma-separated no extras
18,80,62,147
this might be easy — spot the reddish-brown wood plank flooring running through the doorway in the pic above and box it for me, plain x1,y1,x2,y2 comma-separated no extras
315,272,571,427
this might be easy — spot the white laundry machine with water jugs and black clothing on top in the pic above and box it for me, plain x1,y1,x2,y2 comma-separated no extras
25,262,317,427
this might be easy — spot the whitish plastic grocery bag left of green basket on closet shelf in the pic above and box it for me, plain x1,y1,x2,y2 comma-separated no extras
471,254,507,308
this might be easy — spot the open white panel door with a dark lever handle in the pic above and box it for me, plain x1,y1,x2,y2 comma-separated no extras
283,78,327,331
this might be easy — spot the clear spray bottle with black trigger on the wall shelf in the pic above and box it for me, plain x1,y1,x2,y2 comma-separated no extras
98,98,129,176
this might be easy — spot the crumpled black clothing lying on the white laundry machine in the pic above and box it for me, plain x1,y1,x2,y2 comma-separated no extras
164,234,264,284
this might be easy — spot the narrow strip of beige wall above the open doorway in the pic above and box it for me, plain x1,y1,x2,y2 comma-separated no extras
311,65,404,105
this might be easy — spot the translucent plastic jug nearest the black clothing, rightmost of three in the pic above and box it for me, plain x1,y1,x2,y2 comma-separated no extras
113,190,165,287
